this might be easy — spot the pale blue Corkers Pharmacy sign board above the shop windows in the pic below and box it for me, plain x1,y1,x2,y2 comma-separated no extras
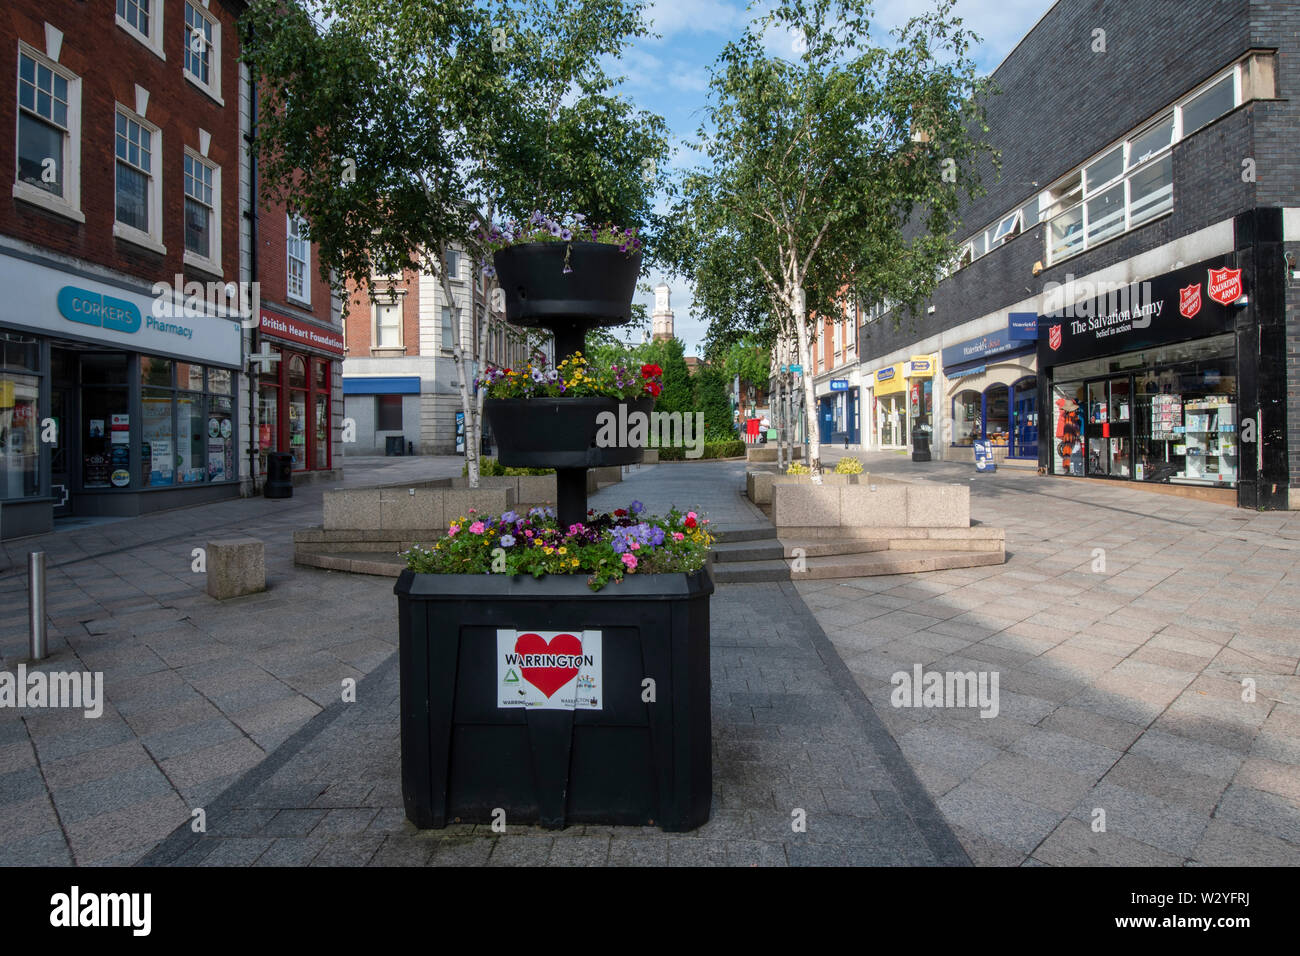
0,254,242,368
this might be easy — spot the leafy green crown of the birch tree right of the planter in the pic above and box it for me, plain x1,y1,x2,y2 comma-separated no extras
660,0,996,359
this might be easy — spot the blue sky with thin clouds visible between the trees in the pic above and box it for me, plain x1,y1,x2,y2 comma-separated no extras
623,0,1054,355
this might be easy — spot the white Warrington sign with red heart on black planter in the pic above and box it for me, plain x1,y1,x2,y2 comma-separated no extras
497,628,603,710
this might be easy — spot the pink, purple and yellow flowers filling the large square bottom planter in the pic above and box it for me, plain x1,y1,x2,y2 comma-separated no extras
402,501,714,591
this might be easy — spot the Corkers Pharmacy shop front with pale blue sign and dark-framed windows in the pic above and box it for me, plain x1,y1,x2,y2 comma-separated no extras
0,254,242,537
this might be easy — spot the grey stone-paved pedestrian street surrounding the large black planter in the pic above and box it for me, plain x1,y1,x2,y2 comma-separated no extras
0,454,1300,866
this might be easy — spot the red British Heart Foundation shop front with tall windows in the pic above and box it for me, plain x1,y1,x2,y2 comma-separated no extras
255,307,343,476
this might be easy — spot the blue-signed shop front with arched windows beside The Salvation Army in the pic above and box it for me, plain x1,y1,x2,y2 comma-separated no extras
943,312,1039,460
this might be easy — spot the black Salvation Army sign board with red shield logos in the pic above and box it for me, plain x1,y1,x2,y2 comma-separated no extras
1039,259,1245,368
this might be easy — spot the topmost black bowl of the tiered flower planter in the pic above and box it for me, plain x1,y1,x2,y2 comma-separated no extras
493,242,641,326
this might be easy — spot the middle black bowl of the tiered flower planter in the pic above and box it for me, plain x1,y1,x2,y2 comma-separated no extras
484,397,654,468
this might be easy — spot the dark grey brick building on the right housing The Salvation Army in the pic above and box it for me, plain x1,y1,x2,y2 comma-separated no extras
861,0,1300,509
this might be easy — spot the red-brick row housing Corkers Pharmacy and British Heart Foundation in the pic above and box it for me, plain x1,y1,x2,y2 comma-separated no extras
0,0,342,537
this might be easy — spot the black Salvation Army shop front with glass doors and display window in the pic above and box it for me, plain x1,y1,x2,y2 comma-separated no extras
1039,259,1253,503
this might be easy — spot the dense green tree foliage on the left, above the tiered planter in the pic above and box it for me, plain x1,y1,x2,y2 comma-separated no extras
241,0,668,291
